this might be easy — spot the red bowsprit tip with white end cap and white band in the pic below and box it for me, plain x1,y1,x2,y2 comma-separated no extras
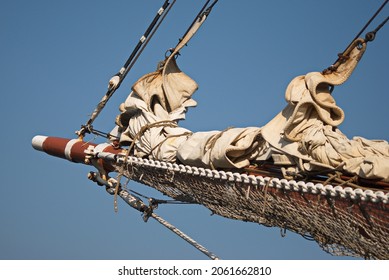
32,135,122,171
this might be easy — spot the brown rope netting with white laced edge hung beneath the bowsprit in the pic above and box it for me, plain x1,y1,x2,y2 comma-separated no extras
107,155,389,259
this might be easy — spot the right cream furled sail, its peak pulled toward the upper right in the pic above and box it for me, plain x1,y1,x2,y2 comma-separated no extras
262,39,389,181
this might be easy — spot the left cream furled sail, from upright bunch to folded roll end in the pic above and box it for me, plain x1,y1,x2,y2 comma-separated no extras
112,57,263,168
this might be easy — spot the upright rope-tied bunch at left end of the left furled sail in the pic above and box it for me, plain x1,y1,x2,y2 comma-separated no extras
116,59,197,161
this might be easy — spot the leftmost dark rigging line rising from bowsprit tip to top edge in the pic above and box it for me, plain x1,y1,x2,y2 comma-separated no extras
76,0,176,138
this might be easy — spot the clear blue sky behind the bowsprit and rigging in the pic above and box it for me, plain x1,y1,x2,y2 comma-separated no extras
0,0,389,259
